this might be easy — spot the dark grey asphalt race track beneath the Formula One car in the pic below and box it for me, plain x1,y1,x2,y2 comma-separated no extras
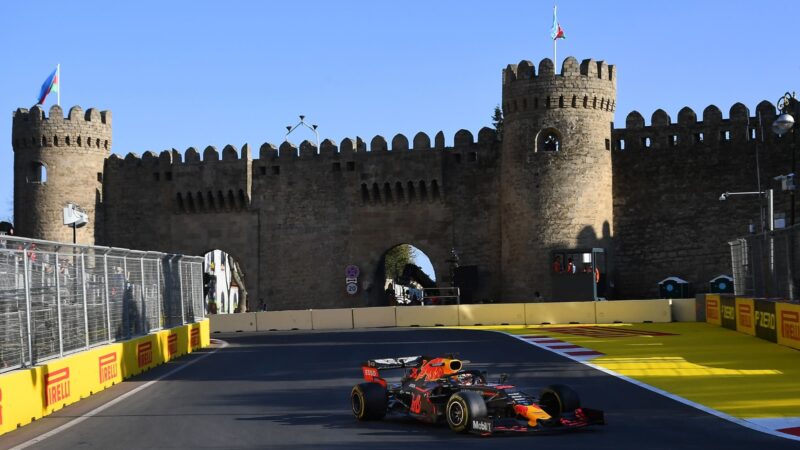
0,329,800,450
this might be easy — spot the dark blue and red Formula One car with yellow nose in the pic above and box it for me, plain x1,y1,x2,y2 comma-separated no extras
350,355,605,436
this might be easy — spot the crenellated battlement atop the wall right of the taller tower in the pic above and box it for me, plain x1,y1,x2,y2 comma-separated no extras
612,100,777,151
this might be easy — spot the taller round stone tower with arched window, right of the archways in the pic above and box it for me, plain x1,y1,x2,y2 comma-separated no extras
500,57,616,298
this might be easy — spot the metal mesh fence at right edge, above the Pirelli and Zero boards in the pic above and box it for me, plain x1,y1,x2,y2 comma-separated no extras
728,225,800,301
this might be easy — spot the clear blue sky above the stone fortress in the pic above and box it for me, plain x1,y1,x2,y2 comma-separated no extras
0,0,800,227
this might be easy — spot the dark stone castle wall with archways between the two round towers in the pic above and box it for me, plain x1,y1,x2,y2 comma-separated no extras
105,129,499,309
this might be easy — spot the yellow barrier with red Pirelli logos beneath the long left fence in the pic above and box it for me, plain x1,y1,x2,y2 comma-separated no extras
0,320,210,434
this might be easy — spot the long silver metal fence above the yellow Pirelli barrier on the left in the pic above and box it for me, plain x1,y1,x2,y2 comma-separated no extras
0,236,205,372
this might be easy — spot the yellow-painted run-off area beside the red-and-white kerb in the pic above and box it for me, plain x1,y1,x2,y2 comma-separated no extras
482,323,800,418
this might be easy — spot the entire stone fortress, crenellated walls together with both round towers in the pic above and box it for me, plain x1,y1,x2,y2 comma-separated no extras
12,57,791,310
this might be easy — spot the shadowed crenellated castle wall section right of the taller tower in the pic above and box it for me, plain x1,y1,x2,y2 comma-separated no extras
613,102,791,298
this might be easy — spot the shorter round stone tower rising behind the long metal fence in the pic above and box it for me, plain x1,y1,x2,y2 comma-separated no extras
11,105,111,244
